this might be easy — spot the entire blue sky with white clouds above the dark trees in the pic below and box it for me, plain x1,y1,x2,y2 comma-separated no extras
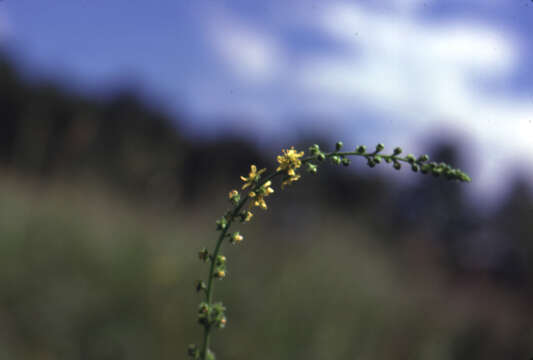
0,0,533,207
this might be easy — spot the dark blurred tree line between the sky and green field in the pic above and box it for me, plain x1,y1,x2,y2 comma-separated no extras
0,54,533,358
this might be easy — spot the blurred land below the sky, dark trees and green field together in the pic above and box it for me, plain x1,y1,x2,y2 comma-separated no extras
0,57,533,359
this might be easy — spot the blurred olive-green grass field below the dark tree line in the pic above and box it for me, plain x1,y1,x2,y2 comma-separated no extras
0,178,533,360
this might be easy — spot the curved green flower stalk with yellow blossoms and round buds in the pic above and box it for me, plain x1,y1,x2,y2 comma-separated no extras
188,141,471,360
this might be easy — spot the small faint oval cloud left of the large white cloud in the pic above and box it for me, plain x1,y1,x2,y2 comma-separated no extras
209,13,283,83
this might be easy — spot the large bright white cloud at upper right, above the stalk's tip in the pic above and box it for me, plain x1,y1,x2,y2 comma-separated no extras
296,1,533,201
